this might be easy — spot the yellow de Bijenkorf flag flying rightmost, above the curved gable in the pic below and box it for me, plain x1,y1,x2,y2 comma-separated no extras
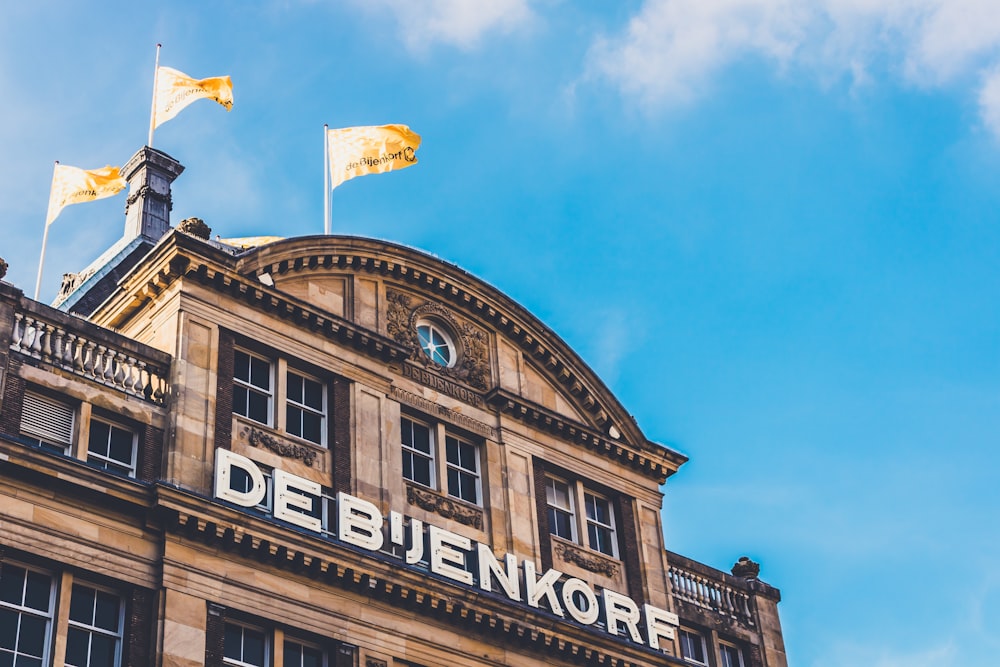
327,125,420,190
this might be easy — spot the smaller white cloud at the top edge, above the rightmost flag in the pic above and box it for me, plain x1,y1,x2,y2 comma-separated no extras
361,0,534,51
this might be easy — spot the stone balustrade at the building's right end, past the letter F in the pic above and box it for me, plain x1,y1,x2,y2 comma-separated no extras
668,553,754,627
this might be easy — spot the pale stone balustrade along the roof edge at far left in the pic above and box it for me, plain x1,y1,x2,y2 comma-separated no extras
10,312,167,405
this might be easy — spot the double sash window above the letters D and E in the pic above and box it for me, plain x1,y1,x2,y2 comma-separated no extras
233,349,327,447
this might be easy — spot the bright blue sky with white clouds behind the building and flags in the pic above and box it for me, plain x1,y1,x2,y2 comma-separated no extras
0,0,1000,667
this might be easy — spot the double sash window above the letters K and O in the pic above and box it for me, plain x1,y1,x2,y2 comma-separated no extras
545,476,618,558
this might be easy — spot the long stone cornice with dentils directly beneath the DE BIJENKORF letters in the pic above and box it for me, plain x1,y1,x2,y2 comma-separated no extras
156,484,683,667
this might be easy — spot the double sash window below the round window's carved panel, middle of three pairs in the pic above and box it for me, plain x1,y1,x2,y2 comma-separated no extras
400,416,483,505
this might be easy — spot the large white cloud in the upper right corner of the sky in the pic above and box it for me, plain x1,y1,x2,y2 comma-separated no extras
588,0,1000,136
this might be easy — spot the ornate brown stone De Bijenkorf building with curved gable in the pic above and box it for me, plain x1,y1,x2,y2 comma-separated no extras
0,148,786,667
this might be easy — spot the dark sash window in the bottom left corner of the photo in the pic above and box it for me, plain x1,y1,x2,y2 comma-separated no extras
0,563,55,667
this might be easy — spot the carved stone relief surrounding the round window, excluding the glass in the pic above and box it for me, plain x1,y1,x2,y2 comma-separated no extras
386,289,490,390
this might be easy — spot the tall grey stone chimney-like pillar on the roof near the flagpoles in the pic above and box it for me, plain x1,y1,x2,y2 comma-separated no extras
122,146,184,243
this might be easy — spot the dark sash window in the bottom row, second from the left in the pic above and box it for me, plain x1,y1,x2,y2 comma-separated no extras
66,584,124,667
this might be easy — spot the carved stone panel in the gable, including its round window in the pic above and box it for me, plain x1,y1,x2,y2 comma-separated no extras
386,289,490,390
